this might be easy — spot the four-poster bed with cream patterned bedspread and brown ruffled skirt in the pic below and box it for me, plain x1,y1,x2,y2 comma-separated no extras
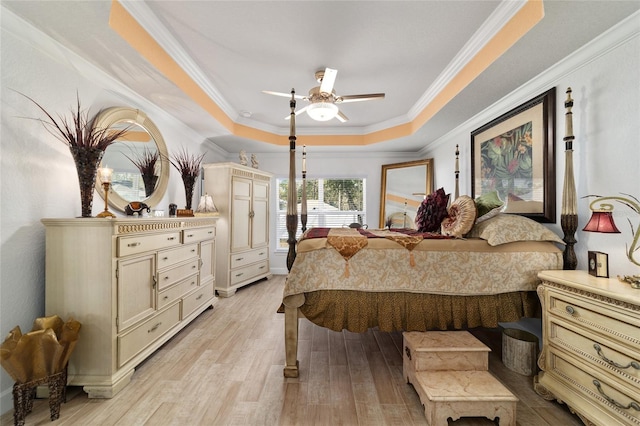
283,94,564,377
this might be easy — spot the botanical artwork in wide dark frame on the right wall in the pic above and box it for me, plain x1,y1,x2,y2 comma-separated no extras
471,88,556,223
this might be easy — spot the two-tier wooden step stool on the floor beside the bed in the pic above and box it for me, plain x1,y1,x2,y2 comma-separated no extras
402,331,518,426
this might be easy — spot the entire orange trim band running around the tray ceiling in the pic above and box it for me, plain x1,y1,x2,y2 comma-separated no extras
109,0,544,146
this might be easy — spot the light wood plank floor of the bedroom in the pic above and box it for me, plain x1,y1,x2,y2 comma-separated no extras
0,276,582,426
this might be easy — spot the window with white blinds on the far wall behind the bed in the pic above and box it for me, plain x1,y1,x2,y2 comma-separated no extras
276,179,366,249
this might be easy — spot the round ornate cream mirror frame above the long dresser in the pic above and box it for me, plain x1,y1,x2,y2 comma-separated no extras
96,107,170,212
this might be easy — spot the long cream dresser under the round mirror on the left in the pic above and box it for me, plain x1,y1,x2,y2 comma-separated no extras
42,218,217,398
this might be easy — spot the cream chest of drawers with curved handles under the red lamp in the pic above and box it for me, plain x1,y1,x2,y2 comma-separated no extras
534,271,640,426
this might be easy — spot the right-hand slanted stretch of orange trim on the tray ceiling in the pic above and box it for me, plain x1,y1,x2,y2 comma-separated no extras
412,0,544,132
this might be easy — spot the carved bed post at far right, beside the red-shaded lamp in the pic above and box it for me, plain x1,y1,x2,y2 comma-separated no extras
560,87,578,269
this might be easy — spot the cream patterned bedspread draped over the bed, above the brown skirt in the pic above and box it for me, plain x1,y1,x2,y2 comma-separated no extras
284,230,562,297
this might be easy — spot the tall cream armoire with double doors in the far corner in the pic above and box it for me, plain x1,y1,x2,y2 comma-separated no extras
202,163,272,297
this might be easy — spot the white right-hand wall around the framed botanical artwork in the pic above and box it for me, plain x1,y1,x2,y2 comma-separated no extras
427,13,640,277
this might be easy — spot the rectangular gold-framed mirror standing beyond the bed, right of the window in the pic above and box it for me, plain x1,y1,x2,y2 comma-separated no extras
380,158,433,228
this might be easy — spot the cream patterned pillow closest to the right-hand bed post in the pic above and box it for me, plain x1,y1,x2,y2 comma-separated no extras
467,213,564,246
